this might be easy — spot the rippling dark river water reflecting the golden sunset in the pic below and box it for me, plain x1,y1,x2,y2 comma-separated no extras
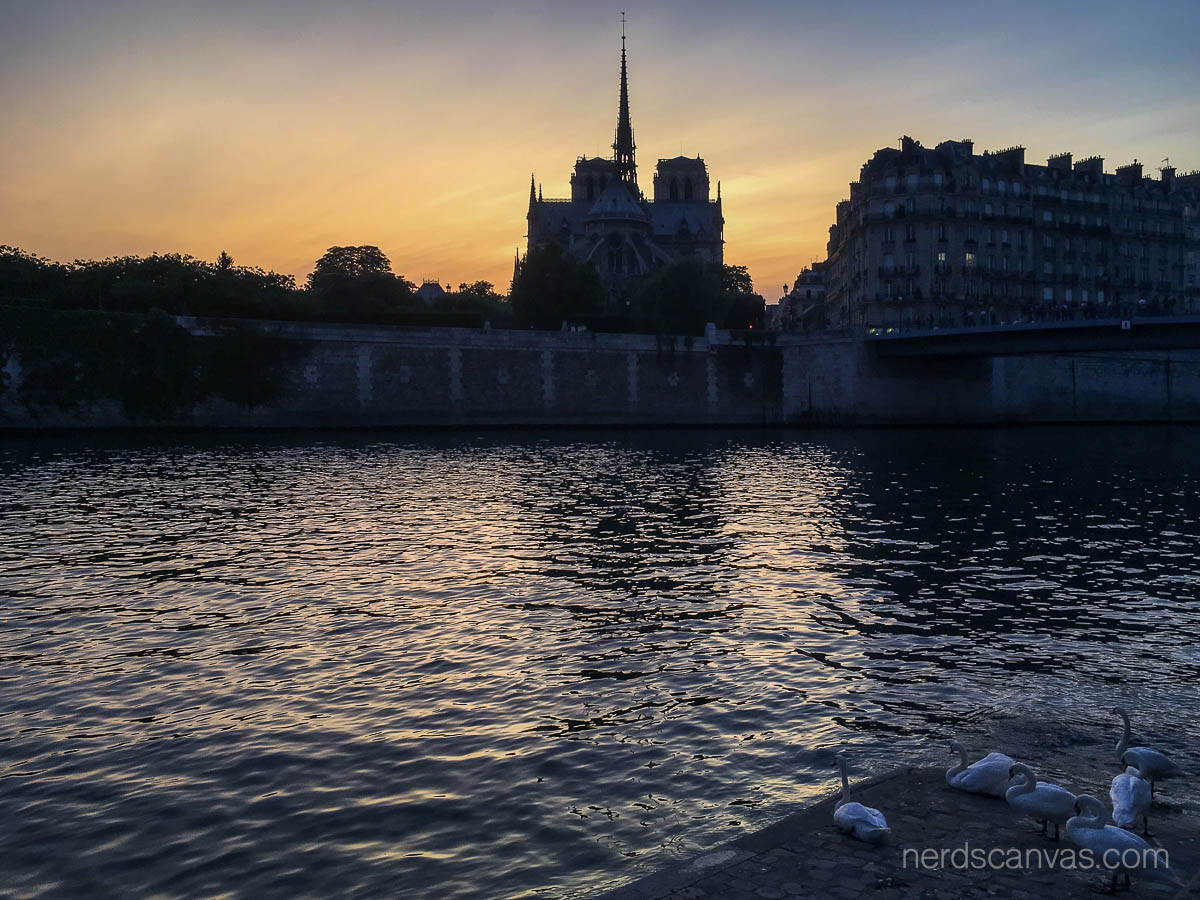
0,427,1200,896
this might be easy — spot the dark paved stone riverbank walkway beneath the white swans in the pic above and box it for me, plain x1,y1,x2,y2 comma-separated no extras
605,757,1200,900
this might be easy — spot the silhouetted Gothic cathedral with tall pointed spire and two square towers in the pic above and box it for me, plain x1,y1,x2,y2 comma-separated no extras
526,29,725,293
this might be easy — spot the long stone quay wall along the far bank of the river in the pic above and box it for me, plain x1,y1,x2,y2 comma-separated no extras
0,318,1200,431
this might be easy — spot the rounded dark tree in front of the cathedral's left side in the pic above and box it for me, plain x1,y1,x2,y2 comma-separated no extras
511,244,605,329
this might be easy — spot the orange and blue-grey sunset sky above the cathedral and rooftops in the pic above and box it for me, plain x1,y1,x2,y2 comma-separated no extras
0,0,1200,300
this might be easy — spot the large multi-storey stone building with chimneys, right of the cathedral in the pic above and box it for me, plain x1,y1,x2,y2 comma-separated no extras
827,137,1200,336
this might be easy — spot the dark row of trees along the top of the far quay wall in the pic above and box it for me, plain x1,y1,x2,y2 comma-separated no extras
0,244,763,335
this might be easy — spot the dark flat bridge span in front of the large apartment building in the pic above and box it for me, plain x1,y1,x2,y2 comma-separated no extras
865,316,1200,358
